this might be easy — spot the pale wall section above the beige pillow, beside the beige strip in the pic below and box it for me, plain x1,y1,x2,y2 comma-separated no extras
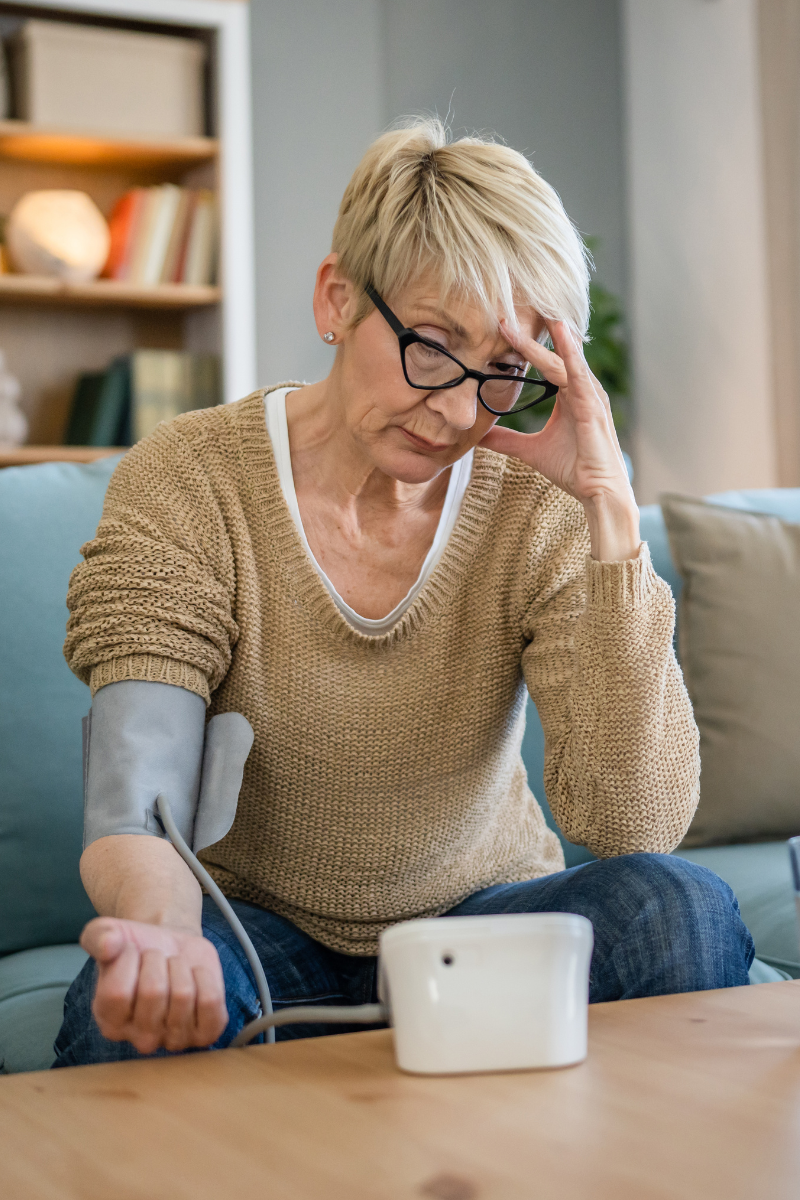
625,0,777,504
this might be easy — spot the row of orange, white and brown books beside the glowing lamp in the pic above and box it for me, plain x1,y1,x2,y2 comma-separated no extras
103,184,217,287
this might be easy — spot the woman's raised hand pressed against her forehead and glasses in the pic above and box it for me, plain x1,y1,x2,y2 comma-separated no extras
481,322,640,562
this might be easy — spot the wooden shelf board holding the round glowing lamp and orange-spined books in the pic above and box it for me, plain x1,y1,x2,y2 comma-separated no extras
0,275,222,310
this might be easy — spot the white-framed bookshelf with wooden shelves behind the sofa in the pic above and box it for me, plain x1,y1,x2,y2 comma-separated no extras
0,0,257,451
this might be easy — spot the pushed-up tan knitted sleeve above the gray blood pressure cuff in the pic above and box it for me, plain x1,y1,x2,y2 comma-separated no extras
64,419,239,703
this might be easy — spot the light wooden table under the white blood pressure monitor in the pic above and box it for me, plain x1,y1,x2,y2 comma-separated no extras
0,982,800,1200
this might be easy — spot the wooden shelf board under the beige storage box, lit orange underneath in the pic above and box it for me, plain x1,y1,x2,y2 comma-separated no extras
0,121,219,170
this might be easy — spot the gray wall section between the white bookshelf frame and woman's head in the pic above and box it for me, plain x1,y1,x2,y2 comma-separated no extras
251,0,385,384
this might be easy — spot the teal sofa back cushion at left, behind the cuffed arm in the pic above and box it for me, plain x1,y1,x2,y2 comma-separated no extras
0,456,119,954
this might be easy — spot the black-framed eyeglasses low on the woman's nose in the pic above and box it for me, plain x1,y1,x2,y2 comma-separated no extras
365,287,558,416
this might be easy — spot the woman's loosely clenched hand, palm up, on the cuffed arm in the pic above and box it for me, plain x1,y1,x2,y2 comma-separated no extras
80,917,228,1054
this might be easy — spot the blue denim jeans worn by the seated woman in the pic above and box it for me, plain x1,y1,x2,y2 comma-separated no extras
54,854,754,1067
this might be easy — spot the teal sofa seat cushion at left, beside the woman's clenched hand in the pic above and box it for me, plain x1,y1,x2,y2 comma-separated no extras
0,946,86,1074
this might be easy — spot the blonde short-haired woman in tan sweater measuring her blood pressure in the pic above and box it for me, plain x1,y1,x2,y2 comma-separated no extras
56,121,753,1066
